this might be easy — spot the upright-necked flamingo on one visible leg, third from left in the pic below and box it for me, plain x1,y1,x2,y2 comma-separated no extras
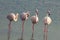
31,9,39,40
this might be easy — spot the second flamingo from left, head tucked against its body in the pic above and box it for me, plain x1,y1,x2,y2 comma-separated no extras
20,11,30,40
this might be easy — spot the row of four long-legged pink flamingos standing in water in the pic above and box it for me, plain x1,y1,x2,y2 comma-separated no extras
7,9,52,40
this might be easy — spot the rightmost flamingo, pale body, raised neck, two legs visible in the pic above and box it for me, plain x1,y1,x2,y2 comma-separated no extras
44,9,52,40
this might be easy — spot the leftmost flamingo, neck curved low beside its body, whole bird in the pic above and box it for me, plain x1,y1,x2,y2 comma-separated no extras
7,13,19,40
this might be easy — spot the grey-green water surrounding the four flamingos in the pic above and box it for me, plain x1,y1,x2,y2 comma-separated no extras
0,0,60,40
